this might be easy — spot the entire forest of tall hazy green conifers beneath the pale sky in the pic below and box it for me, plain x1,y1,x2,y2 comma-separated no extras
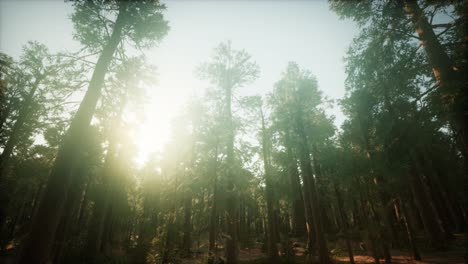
0,0,468,264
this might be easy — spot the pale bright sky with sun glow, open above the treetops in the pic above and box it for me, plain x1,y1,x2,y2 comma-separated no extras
0,0,357,163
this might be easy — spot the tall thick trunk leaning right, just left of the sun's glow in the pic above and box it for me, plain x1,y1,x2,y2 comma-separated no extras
19,2,126,264
